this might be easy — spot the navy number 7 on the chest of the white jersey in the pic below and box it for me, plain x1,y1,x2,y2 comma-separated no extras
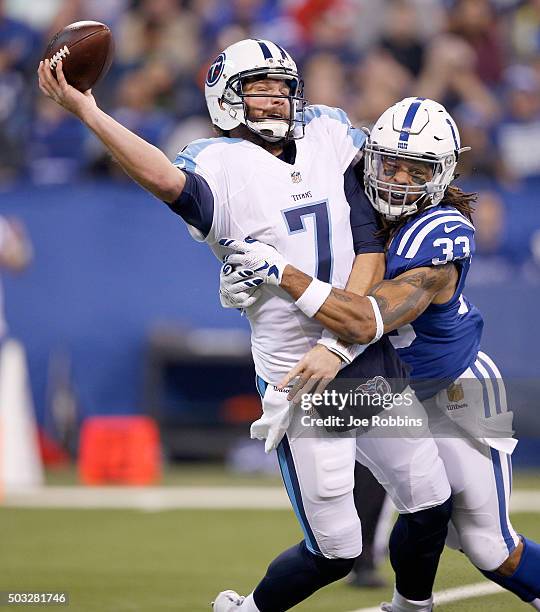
282,200,332,283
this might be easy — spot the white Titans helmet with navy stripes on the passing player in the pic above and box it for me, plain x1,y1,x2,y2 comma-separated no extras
204,39,305,142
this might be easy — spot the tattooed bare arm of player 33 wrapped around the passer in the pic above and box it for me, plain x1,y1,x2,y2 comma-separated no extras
280,263,458,344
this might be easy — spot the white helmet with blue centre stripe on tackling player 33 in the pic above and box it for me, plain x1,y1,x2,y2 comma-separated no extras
364,98,470,219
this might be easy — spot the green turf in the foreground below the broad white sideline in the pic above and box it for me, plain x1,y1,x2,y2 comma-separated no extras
0,508,540,612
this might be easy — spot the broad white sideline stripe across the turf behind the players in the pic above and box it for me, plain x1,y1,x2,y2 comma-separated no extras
0,486,540,513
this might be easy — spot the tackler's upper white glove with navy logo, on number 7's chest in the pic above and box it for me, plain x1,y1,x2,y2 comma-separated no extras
219,237,289,289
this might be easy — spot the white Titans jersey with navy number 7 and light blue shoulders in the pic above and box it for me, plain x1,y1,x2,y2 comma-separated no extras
175,106,365,384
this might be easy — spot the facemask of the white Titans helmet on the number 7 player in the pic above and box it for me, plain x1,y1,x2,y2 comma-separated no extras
220,67,306,142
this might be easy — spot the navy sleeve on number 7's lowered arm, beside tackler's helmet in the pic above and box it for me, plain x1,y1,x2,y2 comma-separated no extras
343,165,384,255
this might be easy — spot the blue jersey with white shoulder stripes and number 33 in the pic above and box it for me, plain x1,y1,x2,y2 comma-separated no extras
385,205,484,400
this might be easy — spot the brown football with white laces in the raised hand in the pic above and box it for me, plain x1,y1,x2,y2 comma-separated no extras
43,21,113,91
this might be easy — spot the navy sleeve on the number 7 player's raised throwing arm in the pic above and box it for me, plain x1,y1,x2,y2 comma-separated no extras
167,170,214,238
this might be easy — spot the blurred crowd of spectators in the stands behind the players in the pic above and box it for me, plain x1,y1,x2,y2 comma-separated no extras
0,0,540,274
